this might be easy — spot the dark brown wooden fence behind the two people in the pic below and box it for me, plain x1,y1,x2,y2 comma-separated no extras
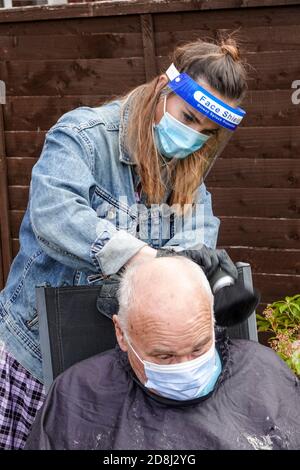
0,0,300,312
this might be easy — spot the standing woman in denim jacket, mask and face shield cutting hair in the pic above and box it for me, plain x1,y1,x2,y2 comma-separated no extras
0,38,246,449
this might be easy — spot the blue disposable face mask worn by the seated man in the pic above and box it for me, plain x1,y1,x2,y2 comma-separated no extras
126,338,222,400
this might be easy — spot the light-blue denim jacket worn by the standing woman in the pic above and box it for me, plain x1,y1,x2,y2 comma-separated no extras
0,97,219,380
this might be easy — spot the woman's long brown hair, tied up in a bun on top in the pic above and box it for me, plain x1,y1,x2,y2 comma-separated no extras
115,32,247,210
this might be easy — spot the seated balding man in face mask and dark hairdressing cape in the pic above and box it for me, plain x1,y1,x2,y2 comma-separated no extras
26,257,300,450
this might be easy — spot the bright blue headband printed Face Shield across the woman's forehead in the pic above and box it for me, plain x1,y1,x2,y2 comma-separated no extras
166,64,246,131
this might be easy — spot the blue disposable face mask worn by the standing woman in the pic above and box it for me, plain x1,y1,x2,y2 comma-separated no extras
154,96,209,159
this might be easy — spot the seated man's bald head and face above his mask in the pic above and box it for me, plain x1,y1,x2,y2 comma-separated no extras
114,256,214,382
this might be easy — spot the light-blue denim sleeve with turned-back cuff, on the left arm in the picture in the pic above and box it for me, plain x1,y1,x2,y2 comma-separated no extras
29,125,145,275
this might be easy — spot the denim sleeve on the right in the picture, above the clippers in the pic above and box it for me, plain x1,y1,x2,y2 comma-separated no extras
162,183,220,251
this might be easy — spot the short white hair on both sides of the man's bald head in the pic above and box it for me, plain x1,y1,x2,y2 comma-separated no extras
118,255,214,333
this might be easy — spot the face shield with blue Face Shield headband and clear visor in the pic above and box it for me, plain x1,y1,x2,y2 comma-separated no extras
166,64,246,180
